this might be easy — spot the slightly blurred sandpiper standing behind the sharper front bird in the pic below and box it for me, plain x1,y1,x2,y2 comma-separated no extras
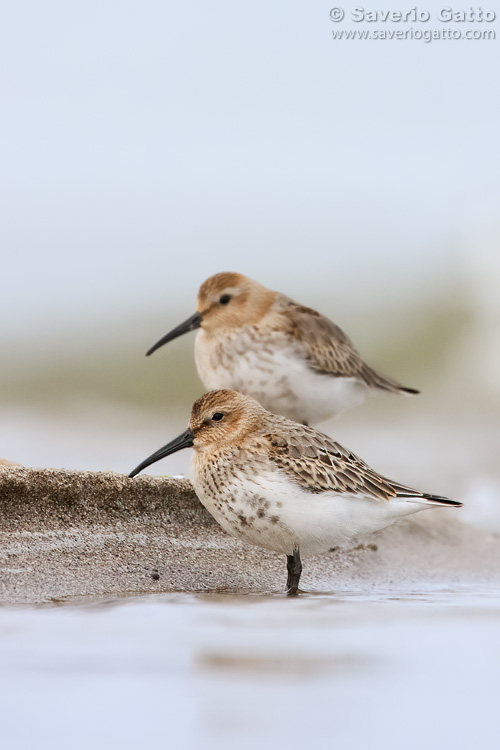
147,273,418,424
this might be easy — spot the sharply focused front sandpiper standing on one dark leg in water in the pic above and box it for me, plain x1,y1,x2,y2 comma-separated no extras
129,390,462,595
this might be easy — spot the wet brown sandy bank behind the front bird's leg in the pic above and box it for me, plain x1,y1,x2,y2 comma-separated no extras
0,466,500,603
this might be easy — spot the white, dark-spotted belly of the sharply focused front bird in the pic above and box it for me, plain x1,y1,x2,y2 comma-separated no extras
192,459,431,555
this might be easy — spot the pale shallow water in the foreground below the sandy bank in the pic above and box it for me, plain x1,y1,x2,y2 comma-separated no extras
0,589,500,750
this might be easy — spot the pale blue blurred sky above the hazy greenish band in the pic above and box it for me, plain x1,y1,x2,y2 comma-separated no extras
0,0,500,345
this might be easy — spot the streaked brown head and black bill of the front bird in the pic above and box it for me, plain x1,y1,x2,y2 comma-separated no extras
129,390,269,477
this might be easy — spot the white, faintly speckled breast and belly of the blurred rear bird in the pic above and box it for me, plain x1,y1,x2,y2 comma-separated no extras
195,331,369,424
